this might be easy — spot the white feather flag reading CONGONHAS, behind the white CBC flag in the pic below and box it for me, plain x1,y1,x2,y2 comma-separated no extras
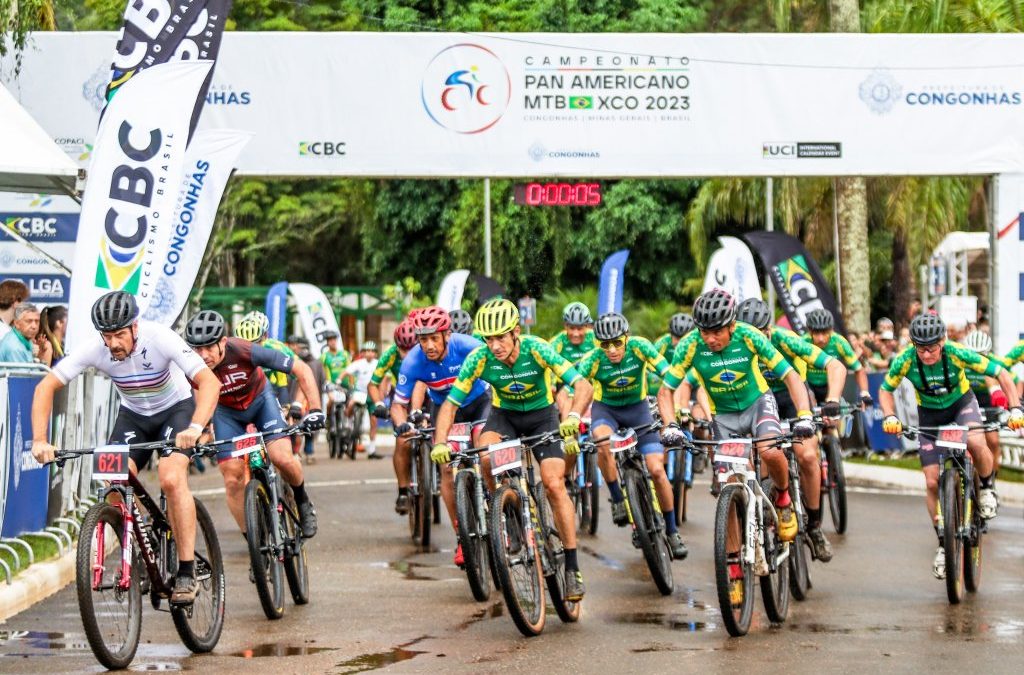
142,129,252,326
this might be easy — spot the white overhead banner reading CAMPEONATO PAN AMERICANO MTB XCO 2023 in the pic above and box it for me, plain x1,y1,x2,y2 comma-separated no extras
2,32,1024,177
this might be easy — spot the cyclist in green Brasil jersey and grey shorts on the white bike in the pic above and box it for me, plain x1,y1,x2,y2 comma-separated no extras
657,289,814,544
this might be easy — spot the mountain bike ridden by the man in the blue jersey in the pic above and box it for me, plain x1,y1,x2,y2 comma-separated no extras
449,422,497,602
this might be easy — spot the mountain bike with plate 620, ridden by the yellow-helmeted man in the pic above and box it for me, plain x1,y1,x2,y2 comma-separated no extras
485,431,582,637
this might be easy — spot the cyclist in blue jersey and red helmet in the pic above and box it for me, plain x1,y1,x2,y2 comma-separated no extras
391,306,490,566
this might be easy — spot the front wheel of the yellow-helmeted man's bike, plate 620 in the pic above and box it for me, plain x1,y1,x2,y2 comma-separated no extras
490,486,547,637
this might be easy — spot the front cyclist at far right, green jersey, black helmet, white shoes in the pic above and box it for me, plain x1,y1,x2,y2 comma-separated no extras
879,314,1024,579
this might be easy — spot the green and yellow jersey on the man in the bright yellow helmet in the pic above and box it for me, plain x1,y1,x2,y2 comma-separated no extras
447,335,580,412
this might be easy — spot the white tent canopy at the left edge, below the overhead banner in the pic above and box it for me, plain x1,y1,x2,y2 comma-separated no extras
0,86,78,195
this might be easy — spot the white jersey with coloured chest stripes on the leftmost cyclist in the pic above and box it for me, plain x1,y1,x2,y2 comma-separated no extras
53,321,206,415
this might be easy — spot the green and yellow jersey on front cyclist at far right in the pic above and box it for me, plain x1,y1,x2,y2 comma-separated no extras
882,341,1002,409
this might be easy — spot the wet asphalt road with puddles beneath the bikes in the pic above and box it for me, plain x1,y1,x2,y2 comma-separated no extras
0,444,1024,675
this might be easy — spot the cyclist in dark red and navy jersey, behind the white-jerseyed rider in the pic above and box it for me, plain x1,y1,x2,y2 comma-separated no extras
185,309,325,538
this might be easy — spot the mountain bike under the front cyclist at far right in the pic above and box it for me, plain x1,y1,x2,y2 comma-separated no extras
903,424,999,604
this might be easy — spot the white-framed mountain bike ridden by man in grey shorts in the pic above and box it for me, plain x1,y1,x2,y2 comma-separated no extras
704,433,793,637
